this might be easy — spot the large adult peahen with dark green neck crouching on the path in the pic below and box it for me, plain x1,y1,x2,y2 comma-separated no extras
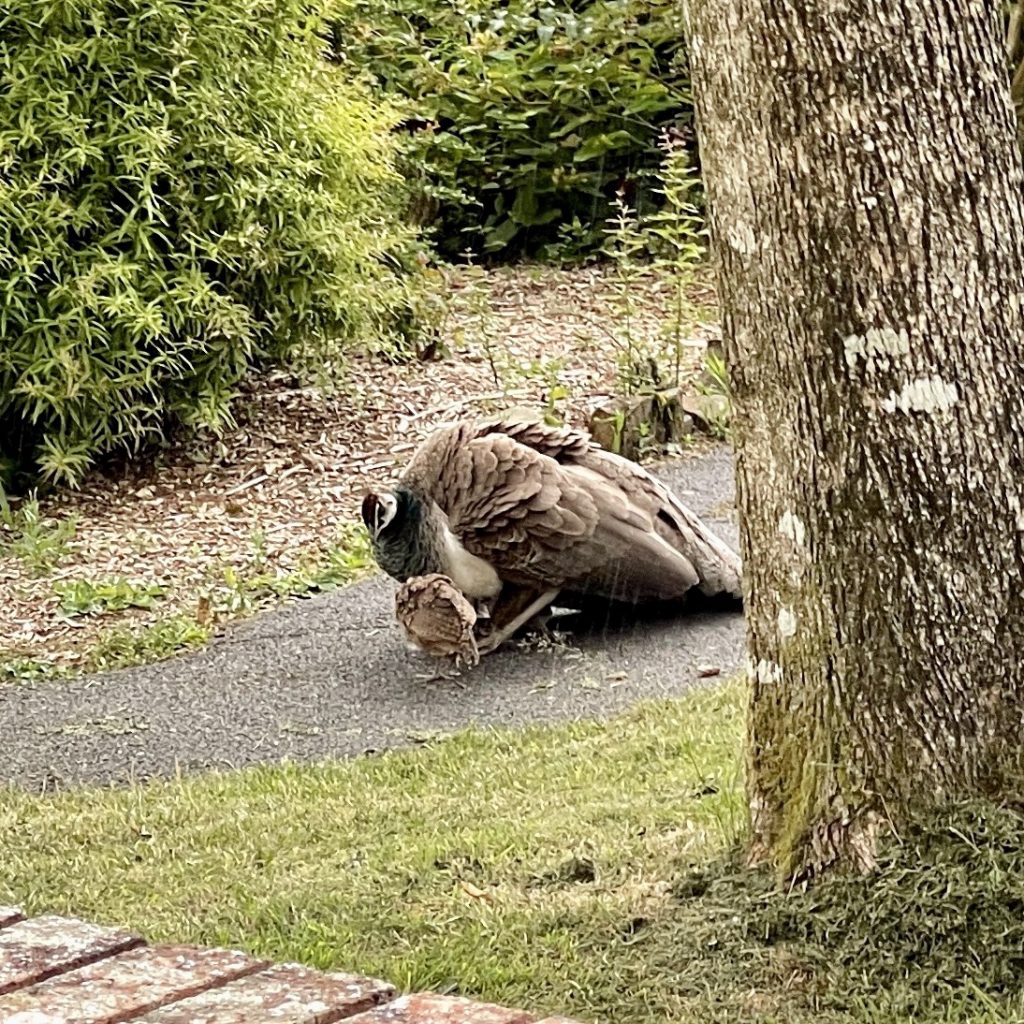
362,420,741,653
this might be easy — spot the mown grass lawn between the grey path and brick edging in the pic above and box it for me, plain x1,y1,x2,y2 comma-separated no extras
0,685,1024,1024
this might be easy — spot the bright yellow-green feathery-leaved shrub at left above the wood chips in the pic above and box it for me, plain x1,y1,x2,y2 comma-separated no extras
0,0,415,482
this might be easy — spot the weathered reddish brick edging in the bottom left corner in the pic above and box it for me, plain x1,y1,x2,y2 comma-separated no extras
0,907,575,1024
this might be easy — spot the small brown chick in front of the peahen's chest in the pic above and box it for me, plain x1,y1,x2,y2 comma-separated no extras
394,572,480,667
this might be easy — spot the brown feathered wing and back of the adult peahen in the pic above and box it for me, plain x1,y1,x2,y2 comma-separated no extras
395,413,716,600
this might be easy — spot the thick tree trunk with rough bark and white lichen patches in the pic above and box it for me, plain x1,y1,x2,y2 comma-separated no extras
687,0,1024,876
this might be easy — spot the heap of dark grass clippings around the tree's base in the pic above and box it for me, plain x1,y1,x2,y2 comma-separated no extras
675,802,1024,1022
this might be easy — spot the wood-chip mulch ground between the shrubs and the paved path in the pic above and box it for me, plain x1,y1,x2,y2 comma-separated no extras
0,267,717,679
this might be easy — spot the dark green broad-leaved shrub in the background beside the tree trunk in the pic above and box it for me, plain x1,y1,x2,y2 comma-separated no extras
333,0,691,258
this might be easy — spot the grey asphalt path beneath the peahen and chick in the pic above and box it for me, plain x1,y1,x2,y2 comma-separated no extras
0,450,743,790
